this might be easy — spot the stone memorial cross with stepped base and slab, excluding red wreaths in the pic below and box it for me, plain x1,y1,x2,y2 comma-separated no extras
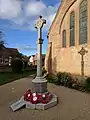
10,16,57,111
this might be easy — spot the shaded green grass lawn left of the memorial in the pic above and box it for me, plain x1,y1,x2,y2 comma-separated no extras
0,70,36,85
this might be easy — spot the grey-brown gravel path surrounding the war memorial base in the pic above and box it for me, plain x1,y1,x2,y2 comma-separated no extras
0,77,90,120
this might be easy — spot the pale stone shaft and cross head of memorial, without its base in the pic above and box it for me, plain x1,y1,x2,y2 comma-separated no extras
35,16,46,77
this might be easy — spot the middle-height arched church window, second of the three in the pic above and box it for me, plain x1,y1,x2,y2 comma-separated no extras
70,11,75,46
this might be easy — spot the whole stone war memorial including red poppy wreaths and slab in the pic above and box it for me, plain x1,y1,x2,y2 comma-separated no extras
10,16,57,111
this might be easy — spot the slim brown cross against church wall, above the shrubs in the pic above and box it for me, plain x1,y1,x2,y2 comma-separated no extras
78,47,88,76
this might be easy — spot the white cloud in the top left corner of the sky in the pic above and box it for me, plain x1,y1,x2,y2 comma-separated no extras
0,0,21,19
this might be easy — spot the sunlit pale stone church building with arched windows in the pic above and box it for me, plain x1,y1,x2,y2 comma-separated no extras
45,0,90,76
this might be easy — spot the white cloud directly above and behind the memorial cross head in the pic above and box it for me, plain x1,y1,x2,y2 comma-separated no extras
25,1,57,30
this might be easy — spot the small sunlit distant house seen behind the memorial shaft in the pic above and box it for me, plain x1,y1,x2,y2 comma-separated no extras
28,54,45,66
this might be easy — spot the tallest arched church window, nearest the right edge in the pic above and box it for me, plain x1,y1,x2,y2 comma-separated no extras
79,0,88,44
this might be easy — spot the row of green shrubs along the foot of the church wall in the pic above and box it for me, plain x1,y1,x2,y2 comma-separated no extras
46,72,90,92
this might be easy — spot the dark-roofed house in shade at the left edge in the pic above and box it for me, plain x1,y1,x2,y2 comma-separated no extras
0,45,20,66
